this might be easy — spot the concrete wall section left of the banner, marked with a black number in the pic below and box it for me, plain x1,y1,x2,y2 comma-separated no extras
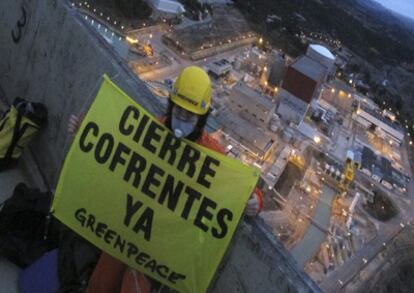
0,0,164,188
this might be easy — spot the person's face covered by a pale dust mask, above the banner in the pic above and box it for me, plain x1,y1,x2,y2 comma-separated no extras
171,105,199,138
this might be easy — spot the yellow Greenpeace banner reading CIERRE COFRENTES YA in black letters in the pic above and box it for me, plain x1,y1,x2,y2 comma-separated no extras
52,76,259,293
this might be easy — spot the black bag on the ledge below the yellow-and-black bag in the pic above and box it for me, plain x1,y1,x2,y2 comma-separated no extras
0,183,59,268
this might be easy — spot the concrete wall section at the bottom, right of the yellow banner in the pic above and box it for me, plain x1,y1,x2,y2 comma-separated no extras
210,219,321,293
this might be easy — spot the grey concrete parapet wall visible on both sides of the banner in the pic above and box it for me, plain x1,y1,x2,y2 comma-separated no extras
0,0,319,293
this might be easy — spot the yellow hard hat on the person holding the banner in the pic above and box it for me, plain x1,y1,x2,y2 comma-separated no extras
170,66,211,115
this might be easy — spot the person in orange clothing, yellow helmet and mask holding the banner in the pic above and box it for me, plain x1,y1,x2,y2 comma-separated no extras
68,66,263,293
